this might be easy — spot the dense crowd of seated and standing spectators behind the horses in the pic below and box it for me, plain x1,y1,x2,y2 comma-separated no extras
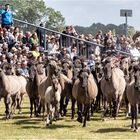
0,5,140,76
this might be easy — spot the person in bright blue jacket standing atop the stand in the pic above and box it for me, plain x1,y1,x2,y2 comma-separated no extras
1,4,13,30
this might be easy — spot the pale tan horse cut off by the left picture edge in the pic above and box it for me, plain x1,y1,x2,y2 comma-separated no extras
0,69,21,119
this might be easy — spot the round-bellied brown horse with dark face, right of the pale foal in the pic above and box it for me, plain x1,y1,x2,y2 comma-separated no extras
72,69,98,127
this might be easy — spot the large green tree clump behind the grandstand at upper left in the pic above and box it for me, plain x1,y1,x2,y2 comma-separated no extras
0,0,65,31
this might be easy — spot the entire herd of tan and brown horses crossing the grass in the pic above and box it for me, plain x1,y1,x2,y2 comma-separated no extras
0,56,140,131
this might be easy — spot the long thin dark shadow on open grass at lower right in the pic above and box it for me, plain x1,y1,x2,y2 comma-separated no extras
91,128,129,133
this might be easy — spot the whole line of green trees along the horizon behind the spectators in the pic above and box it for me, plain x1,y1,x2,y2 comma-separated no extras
0,0,135,35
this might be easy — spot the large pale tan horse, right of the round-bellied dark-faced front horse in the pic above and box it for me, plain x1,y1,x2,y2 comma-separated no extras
101,59,126,118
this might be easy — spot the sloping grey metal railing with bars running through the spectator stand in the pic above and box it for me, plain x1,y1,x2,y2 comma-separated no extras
14,19,139,58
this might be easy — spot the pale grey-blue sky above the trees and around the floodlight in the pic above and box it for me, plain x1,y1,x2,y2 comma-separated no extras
45,0,140,30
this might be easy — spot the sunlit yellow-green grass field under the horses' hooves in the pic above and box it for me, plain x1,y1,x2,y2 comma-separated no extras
0,97,140,140
